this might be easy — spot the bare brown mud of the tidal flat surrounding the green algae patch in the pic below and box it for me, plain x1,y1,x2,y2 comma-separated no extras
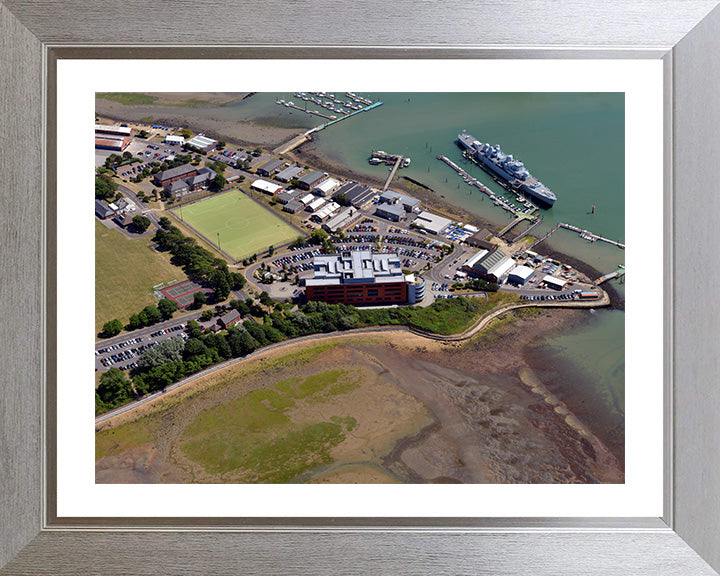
96,310,624,483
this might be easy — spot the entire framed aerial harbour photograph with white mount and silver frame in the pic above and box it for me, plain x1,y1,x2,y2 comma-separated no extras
0,2,720,576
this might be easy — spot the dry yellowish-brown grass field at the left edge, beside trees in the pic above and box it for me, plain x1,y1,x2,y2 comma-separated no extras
95,220,187,333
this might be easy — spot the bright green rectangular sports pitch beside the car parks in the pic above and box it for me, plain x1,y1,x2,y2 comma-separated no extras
173,190,298,260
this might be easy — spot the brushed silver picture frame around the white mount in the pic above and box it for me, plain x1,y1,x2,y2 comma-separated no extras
0,0,720,576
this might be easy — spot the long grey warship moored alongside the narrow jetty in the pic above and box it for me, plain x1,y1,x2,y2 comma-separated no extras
458,132,557,207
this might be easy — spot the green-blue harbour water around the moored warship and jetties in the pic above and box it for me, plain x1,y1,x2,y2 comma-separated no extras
188,92,625,440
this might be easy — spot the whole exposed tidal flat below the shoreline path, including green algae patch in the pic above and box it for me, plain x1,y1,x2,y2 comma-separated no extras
96,310,624,484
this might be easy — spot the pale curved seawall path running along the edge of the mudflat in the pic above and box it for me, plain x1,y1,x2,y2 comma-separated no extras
95,291,610,425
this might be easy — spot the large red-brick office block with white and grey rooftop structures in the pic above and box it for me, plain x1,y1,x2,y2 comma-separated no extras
305,251,415,306
